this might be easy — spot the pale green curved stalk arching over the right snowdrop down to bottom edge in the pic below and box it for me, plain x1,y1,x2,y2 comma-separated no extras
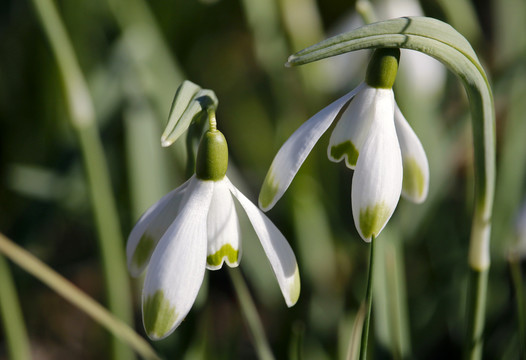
288,17,495,359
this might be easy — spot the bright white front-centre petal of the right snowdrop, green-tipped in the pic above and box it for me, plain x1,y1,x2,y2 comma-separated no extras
351,93,402,241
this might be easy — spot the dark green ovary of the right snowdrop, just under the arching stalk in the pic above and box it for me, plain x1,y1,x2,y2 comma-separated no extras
365,48,400,89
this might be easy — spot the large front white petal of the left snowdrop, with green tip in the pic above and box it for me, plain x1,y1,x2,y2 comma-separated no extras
142,178,213,340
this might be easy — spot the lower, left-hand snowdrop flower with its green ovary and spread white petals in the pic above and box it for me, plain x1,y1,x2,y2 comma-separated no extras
126,118,300,340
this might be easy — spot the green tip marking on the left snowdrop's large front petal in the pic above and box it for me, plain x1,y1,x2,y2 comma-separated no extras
142,290,178,338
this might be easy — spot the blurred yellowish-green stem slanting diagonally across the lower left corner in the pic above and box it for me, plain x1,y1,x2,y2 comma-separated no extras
0,233,159,359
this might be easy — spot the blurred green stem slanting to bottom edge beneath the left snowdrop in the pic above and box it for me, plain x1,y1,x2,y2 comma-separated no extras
228,269,274,360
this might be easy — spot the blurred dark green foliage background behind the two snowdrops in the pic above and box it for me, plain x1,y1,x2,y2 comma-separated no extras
0,0,526,359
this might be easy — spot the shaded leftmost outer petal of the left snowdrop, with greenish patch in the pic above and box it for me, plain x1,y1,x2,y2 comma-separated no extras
126,179,191,276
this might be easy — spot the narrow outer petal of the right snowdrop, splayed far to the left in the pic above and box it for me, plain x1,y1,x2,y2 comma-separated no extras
259,86,361,211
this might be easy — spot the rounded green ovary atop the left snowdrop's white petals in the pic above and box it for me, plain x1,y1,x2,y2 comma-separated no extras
195,130,228,181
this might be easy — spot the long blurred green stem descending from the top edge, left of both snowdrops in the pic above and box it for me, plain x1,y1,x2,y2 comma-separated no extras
29,0,133,359
